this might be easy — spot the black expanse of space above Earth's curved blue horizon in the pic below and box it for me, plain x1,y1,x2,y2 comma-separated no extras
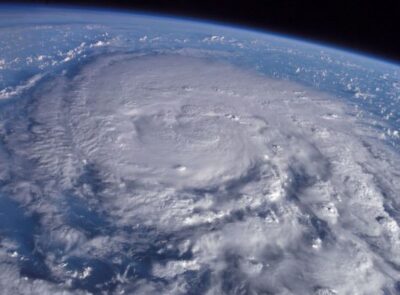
7,0,400,62
